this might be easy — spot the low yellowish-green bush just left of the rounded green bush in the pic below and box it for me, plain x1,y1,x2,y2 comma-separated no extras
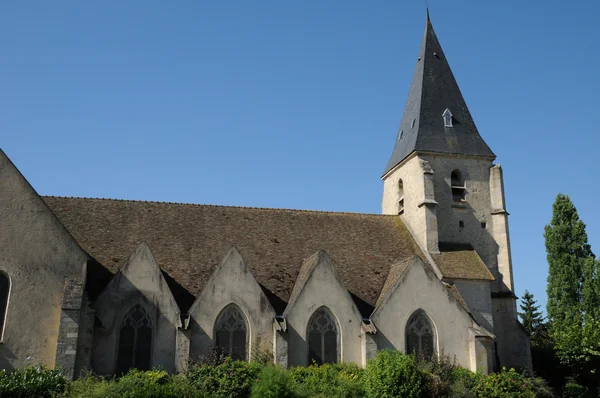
288,363,364,398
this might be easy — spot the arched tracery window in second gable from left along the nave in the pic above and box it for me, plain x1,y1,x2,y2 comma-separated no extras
215,304,248,361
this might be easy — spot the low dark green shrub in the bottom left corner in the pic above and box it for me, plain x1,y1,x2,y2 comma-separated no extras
0,366,67,398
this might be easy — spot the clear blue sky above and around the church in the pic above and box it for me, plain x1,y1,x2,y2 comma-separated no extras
0,0,600,314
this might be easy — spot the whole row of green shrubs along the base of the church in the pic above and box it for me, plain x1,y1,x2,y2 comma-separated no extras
0,358,560,398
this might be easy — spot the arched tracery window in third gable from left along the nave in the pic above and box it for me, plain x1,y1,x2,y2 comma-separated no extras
308,307,340,364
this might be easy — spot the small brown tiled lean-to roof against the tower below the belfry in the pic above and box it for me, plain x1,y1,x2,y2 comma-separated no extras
431,242,494,281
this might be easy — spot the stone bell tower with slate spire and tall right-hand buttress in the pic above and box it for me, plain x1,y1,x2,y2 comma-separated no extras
382,11,519,366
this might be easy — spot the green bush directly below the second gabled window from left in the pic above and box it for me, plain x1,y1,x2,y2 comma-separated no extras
186,358,262,397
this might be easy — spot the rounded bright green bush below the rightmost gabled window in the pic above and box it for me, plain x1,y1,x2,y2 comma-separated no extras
364,350,425,398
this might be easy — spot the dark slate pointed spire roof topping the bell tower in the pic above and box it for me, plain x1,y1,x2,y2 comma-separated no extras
383,10,496,175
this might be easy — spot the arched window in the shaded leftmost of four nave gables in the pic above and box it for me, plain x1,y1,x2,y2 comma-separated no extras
117,304,153,373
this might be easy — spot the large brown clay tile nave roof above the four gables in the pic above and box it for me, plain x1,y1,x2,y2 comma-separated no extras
43,197,423,316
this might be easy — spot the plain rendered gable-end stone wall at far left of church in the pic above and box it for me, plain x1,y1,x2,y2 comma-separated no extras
0,150,88,370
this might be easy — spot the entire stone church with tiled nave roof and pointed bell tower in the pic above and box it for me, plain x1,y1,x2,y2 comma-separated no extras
0,16,531,377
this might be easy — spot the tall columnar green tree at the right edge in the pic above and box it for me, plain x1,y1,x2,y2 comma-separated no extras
544,194,600,392
